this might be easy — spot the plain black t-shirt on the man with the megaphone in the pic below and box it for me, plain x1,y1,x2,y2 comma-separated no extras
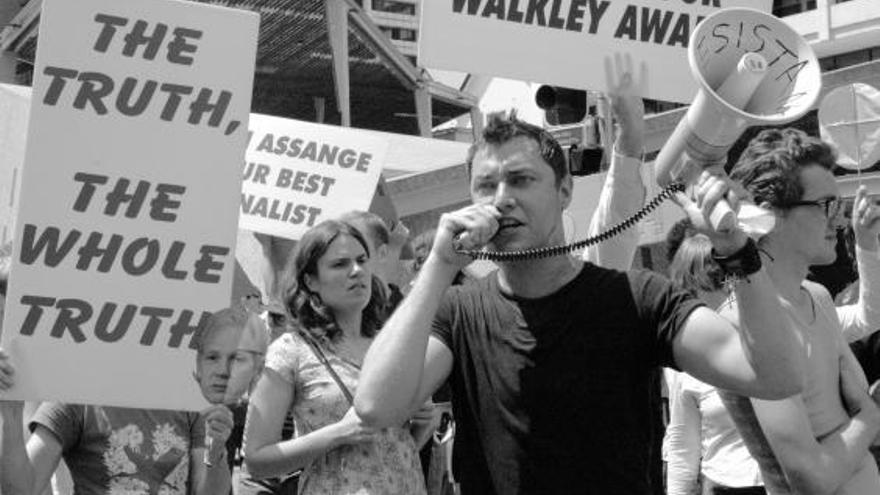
434,263,700,495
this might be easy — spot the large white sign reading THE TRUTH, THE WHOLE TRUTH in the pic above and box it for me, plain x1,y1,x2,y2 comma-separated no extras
2,0,259,410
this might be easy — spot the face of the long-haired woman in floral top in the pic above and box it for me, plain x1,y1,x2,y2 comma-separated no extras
305,234,372,313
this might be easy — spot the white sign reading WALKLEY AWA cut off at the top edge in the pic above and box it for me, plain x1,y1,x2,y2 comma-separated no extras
419,0,772,103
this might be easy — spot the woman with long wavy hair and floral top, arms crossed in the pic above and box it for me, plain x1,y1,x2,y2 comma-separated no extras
245,220,425,495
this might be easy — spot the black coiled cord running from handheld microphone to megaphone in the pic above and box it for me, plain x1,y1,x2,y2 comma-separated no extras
457,182,685,262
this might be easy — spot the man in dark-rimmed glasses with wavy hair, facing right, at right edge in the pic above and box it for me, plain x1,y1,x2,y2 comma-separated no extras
719,129,880,495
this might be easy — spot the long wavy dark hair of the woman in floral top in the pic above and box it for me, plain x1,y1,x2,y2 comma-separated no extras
283,220,387,341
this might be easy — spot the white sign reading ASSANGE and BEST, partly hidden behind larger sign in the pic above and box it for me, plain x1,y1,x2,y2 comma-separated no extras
239,114,388,239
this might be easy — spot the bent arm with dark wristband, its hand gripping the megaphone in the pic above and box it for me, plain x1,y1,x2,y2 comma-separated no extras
673,172,806,399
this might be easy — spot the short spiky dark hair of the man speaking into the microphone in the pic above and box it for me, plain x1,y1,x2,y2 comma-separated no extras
466,110,568,186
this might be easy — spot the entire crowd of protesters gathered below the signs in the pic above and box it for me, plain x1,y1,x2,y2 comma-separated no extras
0,66,880,495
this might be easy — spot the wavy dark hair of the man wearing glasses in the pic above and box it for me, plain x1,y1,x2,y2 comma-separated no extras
730,127,837,208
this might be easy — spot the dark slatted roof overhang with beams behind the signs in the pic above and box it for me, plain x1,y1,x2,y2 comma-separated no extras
0,0,477,134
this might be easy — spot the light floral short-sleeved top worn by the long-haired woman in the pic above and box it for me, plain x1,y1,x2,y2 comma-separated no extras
266,333,425,495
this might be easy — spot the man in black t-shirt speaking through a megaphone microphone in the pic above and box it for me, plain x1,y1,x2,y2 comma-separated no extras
355,68,804,495
